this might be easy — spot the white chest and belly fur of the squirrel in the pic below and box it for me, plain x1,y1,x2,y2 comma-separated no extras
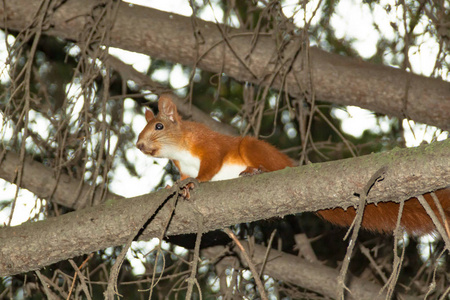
161,148,247,181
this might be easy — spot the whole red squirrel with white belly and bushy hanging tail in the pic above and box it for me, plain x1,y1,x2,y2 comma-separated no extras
136,95,450,234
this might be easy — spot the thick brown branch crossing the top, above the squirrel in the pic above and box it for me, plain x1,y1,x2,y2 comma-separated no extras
0,0,450,130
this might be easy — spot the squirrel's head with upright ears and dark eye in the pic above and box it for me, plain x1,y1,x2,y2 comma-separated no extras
136,94,182,157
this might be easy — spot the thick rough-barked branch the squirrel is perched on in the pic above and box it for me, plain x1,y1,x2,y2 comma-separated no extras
0,140,450,276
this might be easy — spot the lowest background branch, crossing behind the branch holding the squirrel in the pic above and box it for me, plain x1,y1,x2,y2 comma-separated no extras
0,152,412,299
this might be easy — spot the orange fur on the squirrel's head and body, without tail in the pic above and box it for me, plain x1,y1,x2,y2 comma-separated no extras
137,96,293,181
